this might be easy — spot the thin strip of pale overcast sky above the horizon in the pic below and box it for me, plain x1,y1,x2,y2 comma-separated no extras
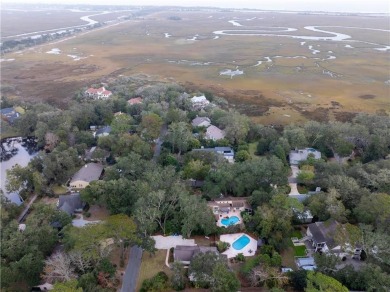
3,0,390,13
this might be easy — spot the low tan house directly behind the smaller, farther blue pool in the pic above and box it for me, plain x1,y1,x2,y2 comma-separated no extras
207,197,252,218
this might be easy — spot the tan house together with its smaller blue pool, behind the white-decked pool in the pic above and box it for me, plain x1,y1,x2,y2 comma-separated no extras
207,197,252,227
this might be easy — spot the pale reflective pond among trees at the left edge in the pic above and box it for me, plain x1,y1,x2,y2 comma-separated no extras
0,137,38,201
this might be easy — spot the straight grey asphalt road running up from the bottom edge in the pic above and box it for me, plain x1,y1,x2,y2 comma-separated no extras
121,246,142,292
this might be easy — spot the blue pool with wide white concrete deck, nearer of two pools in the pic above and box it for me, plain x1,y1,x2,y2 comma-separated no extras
219,233,257,259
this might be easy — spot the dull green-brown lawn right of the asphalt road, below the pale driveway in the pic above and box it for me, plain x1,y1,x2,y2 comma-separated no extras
136,249,171,291
